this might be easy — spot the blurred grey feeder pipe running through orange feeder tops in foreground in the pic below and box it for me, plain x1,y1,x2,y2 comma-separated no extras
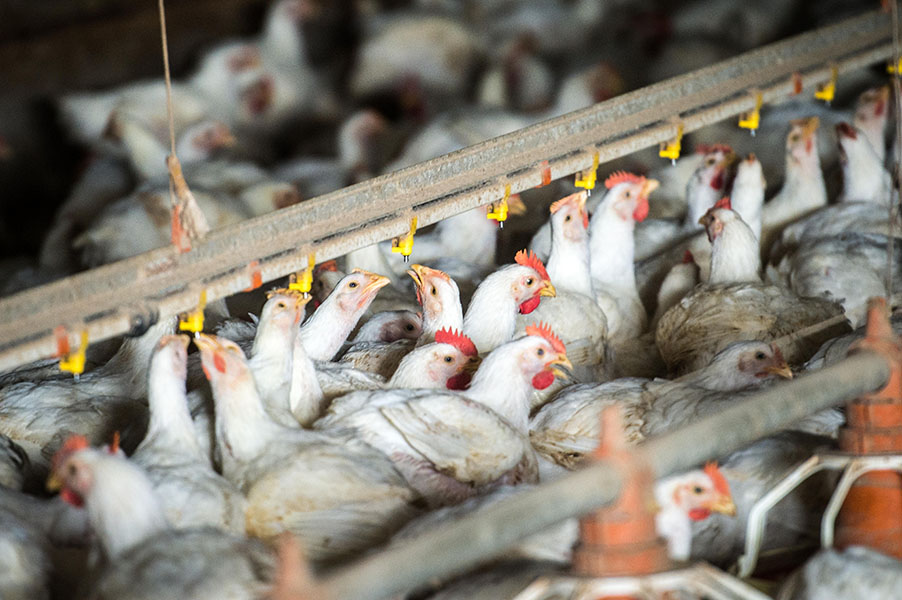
322,352,890,600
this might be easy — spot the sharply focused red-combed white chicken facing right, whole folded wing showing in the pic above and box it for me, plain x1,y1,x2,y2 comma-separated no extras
315,326,571,506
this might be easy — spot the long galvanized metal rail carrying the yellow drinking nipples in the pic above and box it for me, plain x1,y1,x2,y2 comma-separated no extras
0,12,892,371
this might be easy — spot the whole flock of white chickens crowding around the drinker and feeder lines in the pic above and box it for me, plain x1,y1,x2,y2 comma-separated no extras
0,0,902,600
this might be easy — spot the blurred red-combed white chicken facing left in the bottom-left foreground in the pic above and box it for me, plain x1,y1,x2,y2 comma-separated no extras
48,438,273,600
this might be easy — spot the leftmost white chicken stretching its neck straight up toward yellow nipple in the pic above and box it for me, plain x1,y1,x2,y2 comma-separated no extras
131,335,244,535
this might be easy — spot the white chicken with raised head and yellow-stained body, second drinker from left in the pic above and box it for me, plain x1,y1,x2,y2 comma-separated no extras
195,335,417,561
